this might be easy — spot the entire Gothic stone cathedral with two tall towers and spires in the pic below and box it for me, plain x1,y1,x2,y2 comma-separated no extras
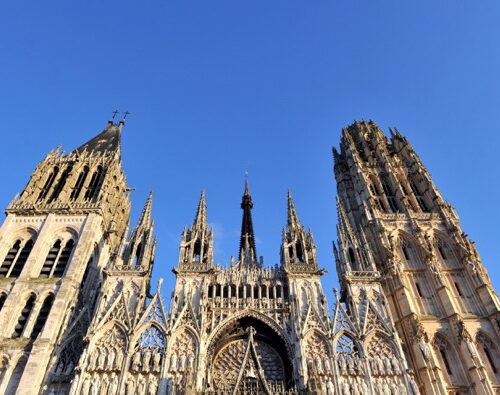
0,120,500,395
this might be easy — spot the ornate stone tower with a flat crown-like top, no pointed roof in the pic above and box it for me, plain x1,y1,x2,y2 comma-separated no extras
333,121,500,395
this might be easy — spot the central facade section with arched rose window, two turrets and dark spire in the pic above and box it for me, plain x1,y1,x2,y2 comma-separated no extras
162,182,333,394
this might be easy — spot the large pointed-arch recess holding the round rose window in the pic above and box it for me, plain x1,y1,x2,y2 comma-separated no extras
208,316,294,394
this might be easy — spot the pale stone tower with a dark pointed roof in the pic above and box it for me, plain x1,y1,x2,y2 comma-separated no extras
0,121,130,394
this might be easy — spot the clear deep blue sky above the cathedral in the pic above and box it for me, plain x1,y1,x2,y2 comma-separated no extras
0,0,500,296
